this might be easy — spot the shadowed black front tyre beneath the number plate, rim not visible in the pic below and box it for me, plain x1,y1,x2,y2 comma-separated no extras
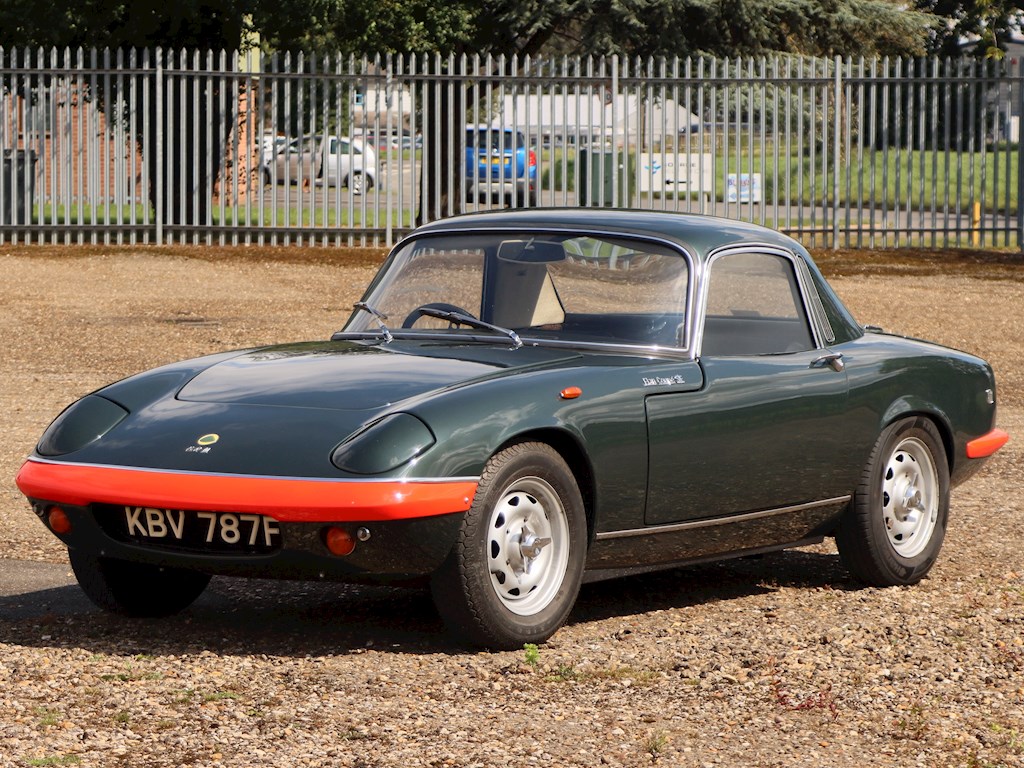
68,549,210,617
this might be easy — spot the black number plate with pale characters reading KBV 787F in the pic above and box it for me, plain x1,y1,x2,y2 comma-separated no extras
109,507,281,554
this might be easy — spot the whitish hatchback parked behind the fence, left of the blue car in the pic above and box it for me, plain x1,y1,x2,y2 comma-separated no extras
262,136,378,195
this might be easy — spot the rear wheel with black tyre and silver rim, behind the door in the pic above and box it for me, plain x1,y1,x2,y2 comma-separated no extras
836,418,949,587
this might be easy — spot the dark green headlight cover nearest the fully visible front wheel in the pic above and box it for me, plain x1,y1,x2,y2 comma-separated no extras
331,414,435,475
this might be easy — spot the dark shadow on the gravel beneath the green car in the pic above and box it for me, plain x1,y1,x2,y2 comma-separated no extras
0,551,855,656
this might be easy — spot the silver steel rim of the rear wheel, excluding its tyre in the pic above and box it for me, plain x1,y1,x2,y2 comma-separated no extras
882,437,940,559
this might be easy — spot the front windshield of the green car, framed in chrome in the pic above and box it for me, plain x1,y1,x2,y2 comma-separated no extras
344,232,691,347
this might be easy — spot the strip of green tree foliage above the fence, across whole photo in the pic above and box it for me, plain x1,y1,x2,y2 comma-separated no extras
6,0,1024,57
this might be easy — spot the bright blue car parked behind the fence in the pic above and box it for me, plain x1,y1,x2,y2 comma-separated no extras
466,126,537,208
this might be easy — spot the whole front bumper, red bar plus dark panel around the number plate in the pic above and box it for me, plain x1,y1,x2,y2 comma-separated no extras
17,459,476,582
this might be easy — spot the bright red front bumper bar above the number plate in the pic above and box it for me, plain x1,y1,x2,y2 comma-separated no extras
16,459,477,522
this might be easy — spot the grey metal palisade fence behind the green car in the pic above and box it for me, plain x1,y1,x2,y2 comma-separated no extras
0,48,1024,248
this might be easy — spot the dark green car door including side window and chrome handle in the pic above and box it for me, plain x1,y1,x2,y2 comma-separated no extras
645,249,853,524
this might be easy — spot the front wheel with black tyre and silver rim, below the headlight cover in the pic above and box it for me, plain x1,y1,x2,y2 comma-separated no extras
430,442,587,650
